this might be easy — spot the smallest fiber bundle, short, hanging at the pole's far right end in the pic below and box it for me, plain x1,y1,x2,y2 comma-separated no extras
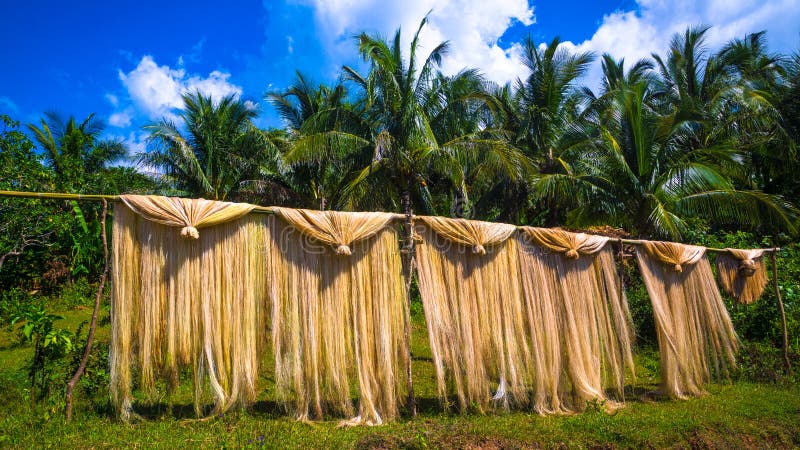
717,248,767,305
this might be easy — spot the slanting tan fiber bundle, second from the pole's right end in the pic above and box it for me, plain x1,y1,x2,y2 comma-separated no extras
637,241,737,398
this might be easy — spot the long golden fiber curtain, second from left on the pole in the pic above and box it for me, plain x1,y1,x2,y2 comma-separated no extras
269,208,408,424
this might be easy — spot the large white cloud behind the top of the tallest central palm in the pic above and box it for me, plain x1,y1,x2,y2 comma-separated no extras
307,0,535,82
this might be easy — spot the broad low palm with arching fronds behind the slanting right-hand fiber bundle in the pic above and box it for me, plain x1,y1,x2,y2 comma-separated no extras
574,59,796,239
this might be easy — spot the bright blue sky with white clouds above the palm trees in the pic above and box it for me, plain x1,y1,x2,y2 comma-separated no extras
0,0,800,160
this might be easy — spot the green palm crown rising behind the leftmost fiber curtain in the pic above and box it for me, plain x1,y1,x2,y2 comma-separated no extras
139,92,275,200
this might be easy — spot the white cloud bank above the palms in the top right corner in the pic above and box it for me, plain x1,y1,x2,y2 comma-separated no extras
566,0,800,87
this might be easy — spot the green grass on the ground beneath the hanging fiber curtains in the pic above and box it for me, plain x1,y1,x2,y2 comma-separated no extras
0,302,800,448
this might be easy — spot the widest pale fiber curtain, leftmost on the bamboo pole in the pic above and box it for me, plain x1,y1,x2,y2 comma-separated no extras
110,195,267,419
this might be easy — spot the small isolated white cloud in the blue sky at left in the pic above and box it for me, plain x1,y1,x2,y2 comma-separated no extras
119,55,242,120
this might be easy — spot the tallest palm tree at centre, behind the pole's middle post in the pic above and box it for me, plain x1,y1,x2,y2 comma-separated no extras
343,17,521,217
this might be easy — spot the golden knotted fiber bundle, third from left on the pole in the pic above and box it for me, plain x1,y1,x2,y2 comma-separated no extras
416,217,532,410
